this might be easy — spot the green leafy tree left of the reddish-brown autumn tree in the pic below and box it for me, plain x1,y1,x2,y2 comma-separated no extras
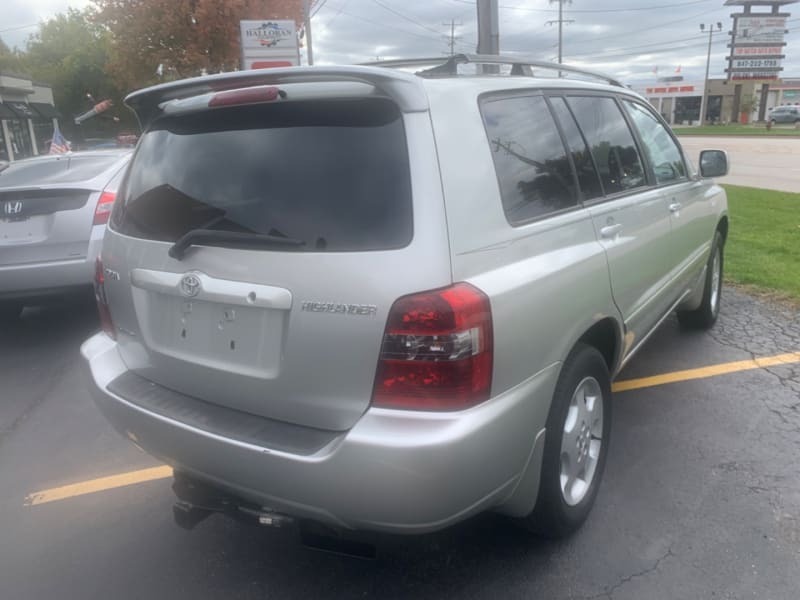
21,9,128,131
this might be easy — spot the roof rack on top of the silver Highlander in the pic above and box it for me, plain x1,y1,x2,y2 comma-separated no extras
362,54,626,87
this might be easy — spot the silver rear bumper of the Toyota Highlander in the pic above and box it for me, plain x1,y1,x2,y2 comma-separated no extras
81,334,558,533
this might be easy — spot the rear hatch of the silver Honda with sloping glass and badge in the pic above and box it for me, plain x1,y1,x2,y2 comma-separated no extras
0,155,122,266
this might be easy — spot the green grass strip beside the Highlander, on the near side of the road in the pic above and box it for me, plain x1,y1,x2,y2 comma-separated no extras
724,185,800,303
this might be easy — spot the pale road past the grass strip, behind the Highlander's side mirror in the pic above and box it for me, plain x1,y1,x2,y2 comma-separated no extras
679,135,800,192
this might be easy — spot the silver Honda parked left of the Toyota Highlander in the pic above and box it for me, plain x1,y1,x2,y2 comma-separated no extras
0,150,131,319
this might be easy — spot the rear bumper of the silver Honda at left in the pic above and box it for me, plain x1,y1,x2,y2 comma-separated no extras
0,226,105,300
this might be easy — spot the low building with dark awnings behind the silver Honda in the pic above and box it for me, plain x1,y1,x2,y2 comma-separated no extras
0,73,60,161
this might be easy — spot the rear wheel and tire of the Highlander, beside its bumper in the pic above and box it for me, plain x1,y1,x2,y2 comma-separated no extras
524,344,611,539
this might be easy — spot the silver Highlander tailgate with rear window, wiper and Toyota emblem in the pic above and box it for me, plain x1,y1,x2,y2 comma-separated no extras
103,91,451,430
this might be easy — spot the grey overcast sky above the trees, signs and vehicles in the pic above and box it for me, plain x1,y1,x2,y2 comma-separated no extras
0,0,800,84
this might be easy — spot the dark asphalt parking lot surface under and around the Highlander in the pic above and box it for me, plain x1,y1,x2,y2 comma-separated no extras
0,289,800,600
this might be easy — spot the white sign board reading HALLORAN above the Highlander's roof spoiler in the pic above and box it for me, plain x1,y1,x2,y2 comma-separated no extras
239,20,300,69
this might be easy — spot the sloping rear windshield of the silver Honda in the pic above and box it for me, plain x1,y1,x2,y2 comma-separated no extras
0,155,122,187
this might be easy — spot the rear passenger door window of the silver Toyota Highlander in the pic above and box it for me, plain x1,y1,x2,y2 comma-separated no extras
568,96,645,194
